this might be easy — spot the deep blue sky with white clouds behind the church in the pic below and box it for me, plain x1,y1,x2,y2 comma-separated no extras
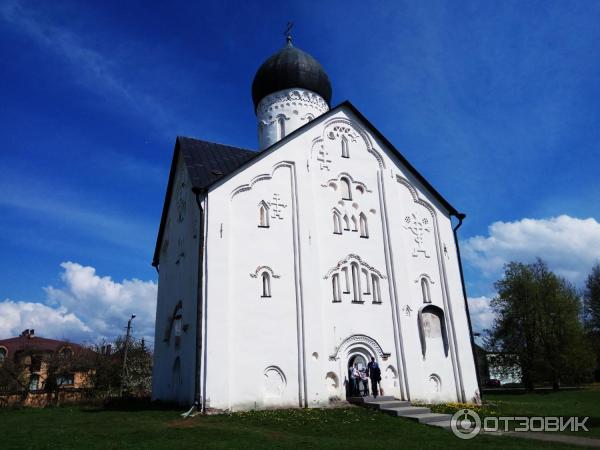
0,0,600,340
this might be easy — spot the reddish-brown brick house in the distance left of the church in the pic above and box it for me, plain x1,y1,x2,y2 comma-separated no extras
0,330,89,392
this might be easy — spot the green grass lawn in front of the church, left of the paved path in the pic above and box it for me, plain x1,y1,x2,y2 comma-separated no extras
0,407,584,450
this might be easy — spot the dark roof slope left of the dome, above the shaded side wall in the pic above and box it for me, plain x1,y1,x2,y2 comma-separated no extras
152,136,257,266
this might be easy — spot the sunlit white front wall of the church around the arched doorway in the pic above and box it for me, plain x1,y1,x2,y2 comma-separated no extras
196,109,477,409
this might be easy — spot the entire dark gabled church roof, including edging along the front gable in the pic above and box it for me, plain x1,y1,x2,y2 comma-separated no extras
152,100,464,267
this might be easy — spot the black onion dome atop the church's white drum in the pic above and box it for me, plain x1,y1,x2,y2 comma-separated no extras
252,42,331,109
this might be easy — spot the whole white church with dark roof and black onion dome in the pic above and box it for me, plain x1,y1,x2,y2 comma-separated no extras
153,37,479,411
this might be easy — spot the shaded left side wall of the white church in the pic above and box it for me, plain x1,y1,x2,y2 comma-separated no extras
152,156,199,404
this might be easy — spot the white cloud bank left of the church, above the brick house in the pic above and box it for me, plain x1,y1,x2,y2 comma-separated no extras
0,262,157,342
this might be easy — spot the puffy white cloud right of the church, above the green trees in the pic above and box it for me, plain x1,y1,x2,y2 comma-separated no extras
461,215,600,285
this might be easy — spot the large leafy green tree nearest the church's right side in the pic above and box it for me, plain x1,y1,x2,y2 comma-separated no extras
487,259,594,390
